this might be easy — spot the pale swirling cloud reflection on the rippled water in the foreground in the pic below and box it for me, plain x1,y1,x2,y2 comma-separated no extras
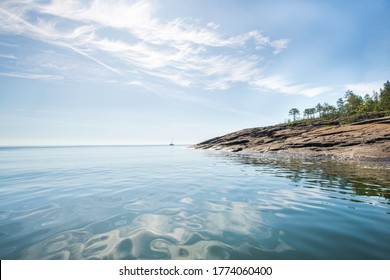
20,202,292,259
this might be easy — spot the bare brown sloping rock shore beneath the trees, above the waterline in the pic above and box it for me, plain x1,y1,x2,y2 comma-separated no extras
192,117,390,161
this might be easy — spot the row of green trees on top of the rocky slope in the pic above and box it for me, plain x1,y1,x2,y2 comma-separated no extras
288,81,390,121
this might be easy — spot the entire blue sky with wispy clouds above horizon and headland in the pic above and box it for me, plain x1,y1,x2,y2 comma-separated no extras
0,0,390,146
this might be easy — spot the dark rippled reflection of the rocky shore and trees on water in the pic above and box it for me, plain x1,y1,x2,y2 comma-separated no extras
210,152,390,201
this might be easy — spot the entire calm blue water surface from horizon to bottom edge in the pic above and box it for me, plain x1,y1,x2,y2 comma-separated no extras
0,146,390,259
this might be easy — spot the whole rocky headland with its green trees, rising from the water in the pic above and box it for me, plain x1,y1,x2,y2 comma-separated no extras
192,81,390,161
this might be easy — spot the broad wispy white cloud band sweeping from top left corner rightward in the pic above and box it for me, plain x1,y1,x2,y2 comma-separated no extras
0,0,327,96
